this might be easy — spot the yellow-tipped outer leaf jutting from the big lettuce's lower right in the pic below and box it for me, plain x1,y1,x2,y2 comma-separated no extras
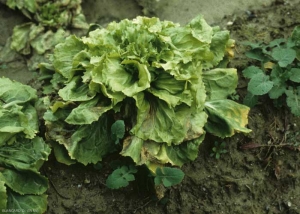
205,100,251,138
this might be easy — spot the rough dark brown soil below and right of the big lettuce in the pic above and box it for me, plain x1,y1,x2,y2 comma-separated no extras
0,1,300,214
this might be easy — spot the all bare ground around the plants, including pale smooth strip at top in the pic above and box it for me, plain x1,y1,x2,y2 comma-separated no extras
0,0,300,214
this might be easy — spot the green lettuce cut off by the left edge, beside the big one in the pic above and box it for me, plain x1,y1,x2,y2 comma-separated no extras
0,78,50,213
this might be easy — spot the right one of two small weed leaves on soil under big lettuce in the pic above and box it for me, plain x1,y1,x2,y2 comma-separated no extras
154,167,184,187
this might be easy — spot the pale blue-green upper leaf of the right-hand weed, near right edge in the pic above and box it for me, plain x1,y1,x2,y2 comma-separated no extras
272,47,296,67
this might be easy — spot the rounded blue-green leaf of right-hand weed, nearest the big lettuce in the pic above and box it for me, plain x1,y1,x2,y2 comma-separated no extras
248,73,274,95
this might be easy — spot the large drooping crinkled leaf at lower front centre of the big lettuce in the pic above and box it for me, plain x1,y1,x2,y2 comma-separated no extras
131,93,206,145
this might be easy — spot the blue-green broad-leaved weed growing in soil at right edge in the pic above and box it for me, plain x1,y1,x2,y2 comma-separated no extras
243,26,300,116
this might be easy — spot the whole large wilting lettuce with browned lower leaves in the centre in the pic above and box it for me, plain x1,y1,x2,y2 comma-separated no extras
41,16,250,180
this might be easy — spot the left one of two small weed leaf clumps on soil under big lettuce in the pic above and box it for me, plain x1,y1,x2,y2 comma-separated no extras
106,165,137,189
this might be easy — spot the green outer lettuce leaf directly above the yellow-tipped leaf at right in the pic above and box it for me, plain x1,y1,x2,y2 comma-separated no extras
202,68,238,100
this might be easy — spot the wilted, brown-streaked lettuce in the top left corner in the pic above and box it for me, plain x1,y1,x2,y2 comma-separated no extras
6,0,88,55
